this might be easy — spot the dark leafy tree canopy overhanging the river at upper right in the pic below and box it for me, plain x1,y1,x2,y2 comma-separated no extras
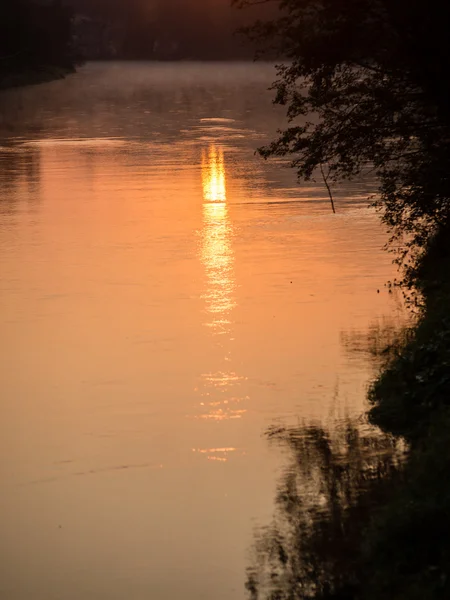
234,0,450,282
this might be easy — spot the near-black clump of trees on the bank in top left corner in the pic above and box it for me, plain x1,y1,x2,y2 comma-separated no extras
0,0,75,87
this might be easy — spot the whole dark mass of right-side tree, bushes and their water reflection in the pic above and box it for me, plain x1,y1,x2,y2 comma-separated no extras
237,0,450,600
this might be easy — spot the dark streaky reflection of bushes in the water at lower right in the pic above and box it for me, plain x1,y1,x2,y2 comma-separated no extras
246,421,401,600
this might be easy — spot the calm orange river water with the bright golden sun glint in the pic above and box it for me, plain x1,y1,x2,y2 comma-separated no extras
0,63,399,600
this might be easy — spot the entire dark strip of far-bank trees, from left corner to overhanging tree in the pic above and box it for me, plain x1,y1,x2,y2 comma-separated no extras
0,0,273,89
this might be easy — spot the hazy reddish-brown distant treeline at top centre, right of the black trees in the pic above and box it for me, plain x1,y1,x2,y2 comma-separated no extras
66,0,269,60
